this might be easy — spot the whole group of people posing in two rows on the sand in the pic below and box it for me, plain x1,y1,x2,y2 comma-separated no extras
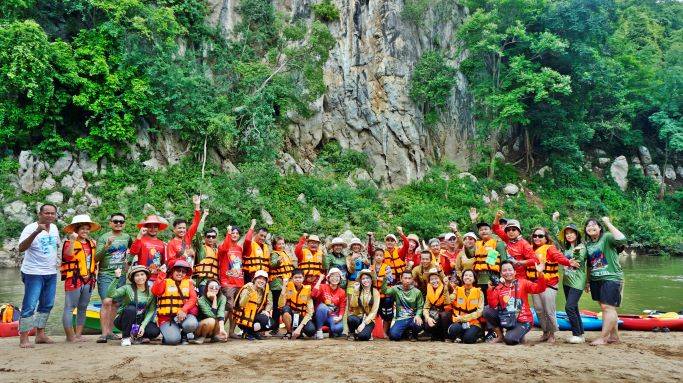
19,196,625,347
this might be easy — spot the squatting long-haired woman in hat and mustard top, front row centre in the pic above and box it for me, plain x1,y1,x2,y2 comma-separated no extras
347,269,380,341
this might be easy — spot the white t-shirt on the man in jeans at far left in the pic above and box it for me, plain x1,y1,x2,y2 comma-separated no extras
19,222,59,275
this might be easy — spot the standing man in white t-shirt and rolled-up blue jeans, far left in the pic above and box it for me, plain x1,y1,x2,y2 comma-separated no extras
19,204,59,348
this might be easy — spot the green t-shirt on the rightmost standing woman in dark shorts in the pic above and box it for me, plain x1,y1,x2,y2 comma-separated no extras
586,232,626,281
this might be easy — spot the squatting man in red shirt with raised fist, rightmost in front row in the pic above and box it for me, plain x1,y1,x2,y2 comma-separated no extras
483,260,545,345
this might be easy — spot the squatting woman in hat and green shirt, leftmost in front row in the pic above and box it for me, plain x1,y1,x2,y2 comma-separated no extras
107,265,161,347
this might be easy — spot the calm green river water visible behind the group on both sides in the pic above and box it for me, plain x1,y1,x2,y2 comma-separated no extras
0,256,683,334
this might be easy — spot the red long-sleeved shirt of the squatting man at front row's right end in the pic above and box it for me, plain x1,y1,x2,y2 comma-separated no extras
486,278,546,323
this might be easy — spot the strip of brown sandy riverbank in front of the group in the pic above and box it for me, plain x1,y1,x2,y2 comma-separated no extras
0,331,683,383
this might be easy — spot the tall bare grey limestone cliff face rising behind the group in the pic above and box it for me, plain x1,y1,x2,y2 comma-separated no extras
276,0,474,186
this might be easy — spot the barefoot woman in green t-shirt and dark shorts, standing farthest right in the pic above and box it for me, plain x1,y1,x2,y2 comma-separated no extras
584,217,626,346
